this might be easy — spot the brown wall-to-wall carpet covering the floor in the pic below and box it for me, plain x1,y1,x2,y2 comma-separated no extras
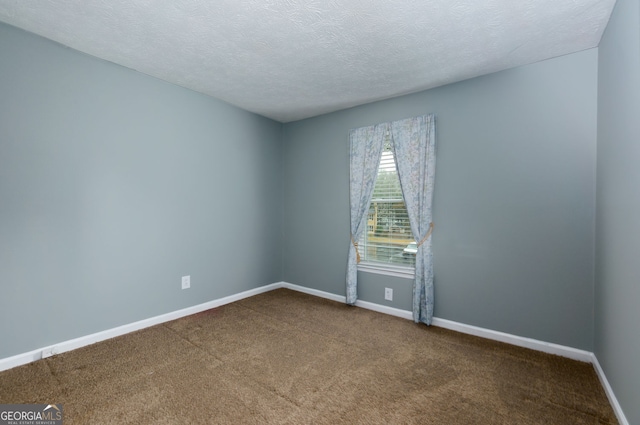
0,289,617,425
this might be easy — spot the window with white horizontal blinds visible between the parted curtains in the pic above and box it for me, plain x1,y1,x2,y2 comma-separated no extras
358,139,417,275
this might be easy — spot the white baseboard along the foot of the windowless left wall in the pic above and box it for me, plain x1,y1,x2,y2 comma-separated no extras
0,283,282,372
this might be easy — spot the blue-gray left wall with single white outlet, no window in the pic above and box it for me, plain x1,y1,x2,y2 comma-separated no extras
0,24,282,358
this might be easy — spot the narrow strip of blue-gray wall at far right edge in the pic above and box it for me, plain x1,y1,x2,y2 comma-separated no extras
595,0,640,424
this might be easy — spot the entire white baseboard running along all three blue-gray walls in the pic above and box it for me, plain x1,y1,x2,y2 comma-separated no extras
0,282,629,425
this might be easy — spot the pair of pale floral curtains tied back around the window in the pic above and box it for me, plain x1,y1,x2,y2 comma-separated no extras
346,115,435,325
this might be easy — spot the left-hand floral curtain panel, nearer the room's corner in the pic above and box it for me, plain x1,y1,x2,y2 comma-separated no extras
347,123,390,305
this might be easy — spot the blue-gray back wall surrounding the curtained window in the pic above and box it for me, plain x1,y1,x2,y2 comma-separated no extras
283,49,598,350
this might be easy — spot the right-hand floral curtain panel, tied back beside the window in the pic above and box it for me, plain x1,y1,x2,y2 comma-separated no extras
391,115,436,325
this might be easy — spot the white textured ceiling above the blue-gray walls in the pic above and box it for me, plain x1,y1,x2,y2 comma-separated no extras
0,0,615,122
